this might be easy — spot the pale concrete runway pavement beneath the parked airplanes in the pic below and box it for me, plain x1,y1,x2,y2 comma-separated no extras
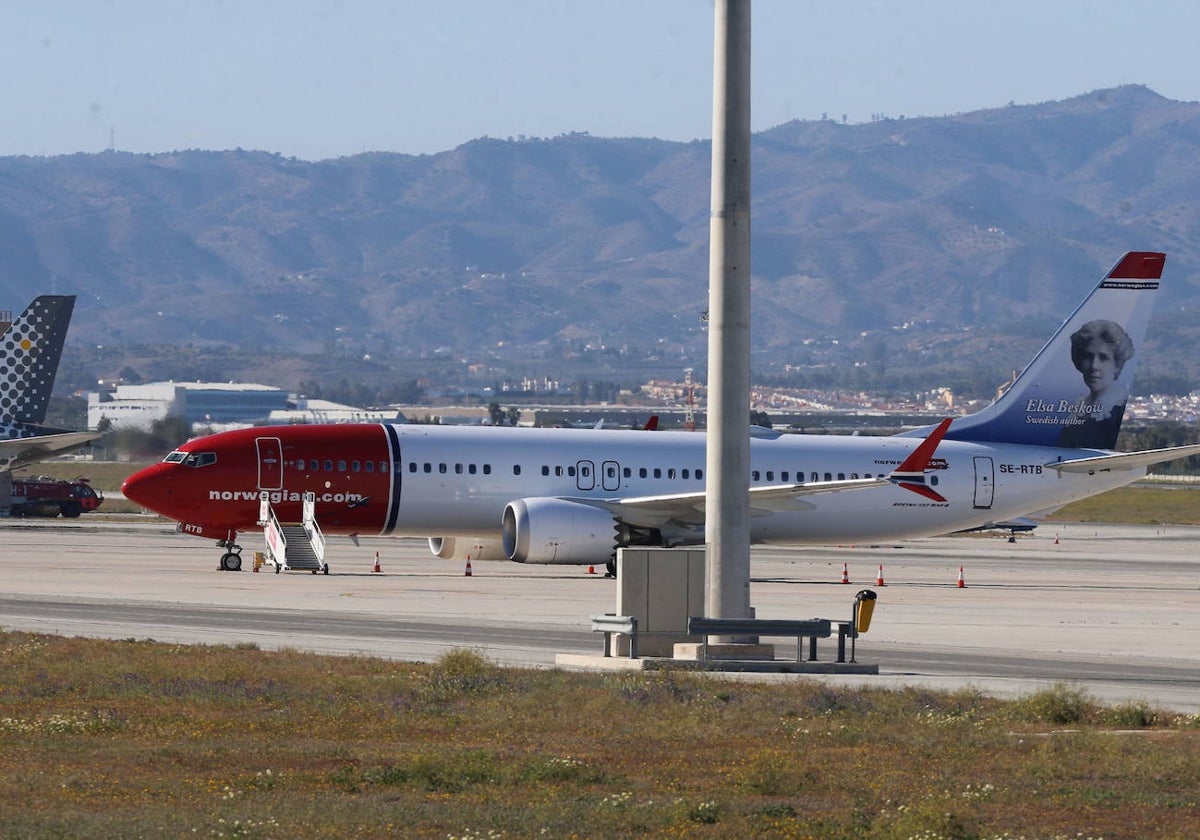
0,516,1200,712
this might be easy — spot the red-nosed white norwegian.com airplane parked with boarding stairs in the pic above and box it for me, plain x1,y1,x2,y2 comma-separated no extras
122,251,1200,574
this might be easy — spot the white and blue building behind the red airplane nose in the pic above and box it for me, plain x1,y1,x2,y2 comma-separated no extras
88,382,288,430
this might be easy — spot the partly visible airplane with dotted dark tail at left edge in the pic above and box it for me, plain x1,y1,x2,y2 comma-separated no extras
0,295,100,472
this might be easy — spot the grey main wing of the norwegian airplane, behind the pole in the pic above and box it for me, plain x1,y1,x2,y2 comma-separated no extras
600,478,892,527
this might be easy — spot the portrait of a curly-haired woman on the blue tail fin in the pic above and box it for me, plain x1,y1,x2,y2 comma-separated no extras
1058,319,1133,449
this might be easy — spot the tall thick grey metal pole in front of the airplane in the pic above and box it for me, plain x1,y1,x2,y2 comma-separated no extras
704,0,750,618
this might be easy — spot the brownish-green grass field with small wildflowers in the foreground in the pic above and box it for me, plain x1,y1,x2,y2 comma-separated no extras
0,632,1200,840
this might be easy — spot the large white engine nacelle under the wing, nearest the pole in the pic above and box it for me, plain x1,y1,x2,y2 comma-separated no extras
502,498,618,565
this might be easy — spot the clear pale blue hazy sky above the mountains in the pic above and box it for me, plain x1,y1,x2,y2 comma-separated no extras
0,0,1200,160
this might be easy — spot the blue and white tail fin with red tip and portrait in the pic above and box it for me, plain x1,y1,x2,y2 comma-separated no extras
946,251,1166,449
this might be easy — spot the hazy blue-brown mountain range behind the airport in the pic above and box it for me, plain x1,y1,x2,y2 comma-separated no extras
0,85,1200,386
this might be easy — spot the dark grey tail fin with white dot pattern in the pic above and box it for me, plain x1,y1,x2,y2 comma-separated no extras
0,295,74,426
